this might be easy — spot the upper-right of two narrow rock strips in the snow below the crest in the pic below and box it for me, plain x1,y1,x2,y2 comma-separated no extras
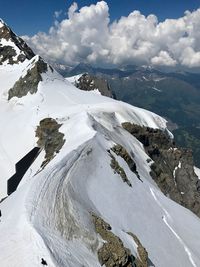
111,144,140,179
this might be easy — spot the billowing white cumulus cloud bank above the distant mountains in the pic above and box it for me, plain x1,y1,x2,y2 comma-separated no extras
24,1,200,68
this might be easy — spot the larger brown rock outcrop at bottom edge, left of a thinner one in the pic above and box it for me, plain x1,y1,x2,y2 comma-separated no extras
92,214,137,267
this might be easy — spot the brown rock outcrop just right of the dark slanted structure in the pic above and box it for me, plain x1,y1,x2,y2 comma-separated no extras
36,118,65,166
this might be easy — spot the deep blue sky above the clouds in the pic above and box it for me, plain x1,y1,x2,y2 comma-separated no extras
0,0,200,35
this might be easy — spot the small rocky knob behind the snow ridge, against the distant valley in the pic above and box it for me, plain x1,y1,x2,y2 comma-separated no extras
75,74,114,98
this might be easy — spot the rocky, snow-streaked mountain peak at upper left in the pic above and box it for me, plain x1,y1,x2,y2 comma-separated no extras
0,20,50,100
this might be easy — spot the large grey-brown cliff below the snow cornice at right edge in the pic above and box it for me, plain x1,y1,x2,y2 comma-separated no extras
122,123,200,217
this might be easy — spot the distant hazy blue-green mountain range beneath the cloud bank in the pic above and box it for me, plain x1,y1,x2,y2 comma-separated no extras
57,63,200,166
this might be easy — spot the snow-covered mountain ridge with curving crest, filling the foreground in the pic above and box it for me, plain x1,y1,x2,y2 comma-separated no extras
0,19,200,267
